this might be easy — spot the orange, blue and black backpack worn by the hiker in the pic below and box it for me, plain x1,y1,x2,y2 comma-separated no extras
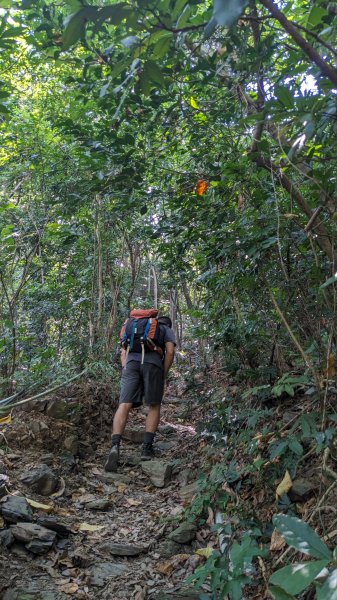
119,308,165,362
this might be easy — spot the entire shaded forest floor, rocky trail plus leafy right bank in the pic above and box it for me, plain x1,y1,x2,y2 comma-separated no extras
0,373,337,600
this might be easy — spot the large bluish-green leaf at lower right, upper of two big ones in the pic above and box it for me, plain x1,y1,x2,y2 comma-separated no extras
273,515,332,560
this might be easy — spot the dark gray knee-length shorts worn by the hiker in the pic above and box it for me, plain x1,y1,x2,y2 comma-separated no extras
119,360,164,407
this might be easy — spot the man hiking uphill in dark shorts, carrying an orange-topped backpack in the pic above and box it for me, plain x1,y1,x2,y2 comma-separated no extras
104,309,176,471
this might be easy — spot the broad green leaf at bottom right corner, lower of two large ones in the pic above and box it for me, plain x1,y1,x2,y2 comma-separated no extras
269,559,329,595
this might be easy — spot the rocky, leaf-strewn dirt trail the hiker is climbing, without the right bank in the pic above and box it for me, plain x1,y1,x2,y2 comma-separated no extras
0,390,210,600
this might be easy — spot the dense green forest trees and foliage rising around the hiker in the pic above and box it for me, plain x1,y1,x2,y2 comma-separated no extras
0,0,337,598
